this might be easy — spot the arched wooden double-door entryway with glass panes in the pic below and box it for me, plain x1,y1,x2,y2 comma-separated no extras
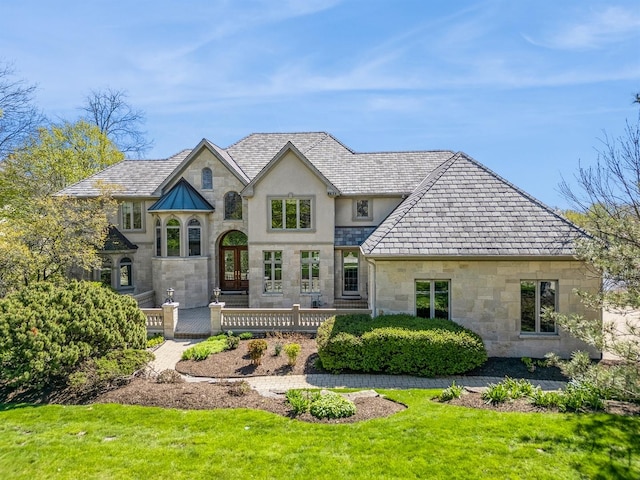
218,230,249,291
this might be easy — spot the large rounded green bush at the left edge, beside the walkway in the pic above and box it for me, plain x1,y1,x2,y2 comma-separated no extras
0,281,147,390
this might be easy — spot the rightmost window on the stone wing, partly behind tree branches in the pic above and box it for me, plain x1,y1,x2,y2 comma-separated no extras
520,280,558,334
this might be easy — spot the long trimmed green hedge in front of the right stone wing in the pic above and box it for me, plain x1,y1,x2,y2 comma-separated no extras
316,314,487,377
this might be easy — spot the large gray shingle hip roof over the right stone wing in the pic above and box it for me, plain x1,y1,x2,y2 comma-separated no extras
362,153,583,256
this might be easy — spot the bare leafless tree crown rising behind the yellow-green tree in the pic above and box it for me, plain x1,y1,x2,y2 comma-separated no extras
82,88,153,157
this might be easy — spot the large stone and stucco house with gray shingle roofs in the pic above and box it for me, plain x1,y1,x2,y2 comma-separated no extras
62,132,600,356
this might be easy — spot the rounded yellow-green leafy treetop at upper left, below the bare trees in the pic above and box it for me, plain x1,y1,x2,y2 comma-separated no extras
0,120,124,207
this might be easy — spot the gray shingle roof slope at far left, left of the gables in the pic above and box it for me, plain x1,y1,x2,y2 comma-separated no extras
58,150,191,197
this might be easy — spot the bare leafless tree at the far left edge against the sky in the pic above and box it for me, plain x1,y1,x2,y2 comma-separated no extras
0,64,45,161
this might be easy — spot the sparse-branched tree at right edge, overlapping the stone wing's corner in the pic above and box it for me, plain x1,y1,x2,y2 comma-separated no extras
548,96,640,400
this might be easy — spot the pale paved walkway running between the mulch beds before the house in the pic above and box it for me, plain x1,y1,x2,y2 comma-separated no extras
151,340,566,394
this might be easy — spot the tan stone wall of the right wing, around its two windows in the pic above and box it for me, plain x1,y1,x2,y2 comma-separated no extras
370,260,600,358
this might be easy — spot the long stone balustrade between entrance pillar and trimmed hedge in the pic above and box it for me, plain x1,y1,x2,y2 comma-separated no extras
209,303,371,334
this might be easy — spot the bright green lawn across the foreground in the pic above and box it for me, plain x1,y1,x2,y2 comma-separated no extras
0,390,640,480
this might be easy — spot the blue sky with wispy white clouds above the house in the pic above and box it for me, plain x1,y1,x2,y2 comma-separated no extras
0,0,640,207
